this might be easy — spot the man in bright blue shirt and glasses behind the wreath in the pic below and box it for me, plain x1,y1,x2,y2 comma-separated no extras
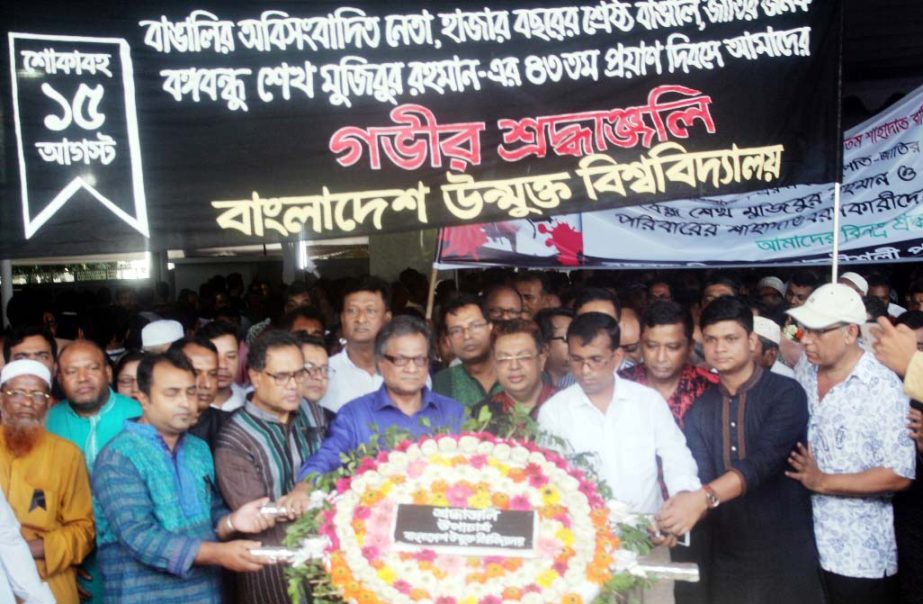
294,315,465,484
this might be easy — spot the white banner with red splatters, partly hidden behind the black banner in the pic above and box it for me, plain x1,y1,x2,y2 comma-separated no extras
439,87,923,268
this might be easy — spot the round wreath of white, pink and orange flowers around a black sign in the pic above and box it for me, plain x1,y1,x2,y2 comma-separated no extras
288,433,650,604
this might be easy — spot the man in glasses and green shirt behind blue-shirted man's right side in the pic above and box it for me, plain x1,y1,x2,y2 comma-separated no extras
433,294,500,407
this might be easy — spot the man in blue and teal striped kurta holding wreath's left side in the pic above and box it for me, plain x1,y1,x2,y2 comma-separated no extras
93,352,275,604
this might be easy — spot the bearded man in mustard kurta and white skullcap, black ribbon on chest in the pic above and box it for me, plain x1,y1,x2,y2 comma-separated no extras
0,360,95,604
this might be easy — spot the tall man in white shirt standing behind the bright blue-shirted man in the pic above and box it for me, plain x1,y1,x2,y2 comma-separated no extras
320,277,391,413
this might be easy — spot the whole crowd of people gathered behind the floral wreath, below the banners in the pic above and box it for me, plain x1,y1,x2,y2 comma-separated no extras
0,269,923,604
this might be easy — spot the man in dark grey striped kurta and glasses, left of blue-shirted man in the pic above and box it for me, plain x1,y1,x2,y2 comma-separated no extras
215,329,326,604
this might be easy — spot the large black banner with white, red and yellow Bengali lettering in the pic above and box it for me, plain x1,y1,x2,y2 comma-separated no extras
0,0,840,257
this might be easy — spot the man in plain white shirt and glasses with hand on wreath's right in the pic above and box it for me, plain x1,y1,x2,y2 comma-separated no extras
538,312,702,514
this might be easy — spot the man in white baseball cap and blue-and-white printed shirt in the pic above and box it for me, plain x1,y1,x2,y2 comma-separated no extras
786,283,915,604
